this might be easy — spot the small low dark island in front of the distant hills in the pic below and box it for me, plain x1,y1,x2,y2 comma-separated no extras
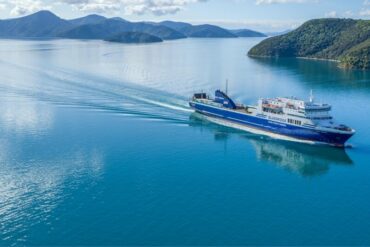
105,32,163,44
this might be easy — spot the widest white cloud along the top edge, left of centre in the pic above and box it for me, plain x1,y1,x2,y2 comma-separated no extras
59,0,208,15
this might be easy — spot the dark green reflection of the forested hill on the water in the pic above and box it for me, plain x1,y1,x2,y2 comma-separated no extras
252,58,370,90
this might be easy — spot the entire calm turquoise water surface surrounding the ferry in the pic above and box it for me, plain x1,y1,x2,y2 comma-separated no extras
0,39,370,245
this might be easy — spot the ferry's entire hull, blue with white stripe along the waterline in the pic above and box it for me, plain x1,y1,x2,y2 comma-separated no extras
190,102,353,147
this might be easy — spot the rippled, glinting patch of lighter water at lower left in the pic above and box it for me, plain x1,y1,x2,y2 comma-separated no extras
0,148,104,244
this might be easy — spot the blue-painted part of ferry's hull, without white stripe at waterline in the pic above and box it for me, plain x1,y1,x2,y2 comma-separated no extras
189,102,353,147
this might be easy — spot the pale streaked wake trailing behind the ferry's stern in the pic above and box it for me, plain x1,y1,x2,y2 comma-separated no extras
0,60,192,123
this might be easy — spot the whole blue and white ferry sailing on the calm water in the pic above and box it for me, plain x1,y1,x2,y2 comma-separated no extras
189,90,355,147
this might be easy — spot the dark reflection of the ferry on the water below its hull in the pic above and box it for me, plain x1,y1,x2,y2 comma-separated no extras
189,113,353,177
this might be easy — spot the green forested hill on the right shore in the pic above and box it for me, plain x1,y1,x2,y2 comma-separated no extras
248,18,370,69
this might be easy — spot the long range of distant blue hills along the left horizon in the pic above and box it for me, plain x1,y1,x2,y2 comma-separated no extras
0,10,266,43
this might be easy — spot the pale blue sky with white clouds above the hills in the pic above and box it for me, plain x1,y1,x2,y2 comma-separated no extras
0,0,370,32
